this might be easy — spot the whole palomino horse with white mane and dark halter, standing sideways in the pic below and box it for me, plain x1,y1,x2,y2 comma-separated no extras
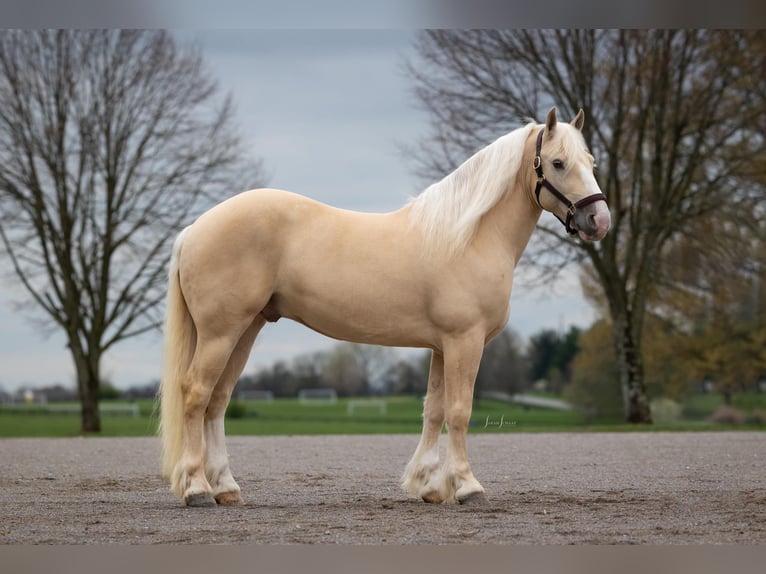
160,108,610,506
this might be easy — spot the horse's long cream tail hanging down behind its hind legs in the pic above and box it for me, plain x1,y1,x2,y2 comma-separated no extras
157,228,197,488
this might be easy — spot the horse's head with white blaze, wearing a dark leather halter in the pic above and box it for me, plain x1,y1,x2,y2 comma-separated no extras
533,108,611,241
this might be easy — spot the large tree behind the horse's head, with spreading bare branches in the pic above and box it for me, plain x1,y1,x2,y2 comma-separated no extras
409,30,766,422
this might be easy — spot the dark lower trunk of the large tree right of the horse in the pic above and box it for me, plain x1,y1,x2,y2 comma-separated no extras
612,313,652,424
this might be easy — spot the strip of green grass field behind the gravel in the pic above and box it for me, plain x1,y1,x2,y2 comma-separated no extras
0,394,766,437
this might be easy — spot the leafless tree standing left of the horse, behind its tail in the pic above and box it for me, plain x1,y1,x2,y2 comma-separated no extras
0,30,258,432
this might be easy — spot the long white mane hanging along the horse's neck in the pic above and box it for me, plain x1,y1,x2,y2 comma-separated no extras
409,123,537,255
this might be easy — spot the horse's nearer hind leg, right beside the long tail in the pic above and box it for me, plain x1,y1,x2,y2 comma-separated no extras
171,332,246,506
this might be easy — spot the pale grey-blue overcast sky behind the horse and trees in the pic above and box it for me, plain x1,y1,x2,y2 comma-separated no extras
0,30,594,390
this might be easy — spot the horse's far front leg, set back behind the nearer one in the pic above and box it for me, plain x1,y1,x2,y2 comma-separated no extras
402,351,444,502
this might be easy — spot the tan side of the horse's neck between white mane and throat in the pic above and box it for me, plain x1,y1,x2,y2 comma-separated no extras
477,177,542,267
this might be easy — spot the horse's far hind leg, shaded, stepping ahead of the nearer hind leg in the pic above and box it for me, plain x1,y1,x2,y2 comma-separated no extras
205,315,265,506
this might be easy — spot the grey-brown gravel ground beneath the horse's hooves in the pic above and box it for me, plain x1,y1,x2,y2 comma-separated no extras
0,432,766,544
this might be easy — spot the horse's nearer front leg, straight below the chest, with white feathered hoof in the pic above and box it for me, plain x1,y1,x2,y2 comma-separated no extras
439,333,484,504
